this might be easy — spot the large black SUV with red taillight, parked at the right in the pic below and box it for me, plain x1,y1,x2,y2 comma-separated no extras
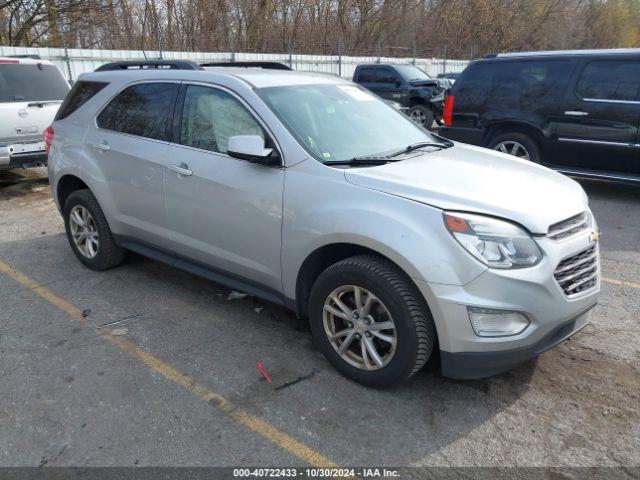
439,49,640,182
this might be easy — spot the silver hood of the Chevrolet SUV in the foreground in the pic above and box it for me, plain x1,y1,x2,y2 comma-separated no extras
345,143,587,234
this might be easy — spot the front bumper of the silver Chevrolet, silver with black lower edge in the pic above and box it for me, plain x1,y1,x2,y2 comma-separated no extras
416,231,600,378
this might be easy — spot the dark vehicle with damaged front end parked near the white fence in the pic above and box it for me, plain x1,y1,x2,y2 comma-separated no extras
353,63,450,128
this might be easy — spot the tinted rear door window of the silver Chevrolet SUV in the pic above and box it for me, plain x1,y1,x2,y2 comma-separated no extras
98,83,179,140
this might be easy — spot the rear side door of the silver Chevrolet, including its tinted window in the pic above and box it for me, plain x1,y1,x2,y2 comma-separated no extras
85,82,180,247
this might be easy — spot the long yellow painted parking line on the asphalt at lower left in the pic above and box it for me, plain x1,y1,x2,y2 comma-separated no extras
0,260,338,467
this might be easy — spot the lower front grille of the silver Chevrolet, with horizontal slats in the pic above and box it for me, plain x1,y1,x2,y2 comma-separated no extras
553,248,598,297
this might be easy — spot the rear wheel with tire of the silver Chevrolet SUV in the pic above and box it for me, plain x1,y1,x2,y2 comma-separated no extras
64,190,124,270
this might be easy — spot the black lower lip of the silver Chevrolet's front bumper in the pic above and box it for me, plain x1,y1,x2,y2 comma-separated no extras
440,303,596,380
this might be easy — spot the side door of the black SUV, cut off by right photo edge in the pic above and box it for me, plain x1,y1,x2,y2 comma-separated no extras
553,56,640,175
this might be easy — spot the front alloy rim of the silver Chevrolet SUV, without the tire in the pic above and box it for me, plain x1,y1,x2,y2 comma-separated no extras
323,285,398,371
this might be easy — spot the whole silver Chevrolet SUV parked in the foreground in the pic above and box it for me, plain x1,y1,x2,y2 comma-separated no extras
46,62,600,387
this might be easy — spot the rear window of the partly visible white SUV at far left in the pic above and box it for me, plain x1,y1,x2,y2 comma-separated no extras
0,63,69,103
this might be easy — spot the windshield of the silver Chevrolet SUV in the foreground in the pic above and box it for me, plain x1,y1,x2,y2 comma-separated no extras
257,84,437,163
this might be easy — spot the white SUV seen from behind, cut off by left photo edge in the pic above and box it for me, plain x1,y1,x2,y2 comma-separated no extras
0,57,69,170
